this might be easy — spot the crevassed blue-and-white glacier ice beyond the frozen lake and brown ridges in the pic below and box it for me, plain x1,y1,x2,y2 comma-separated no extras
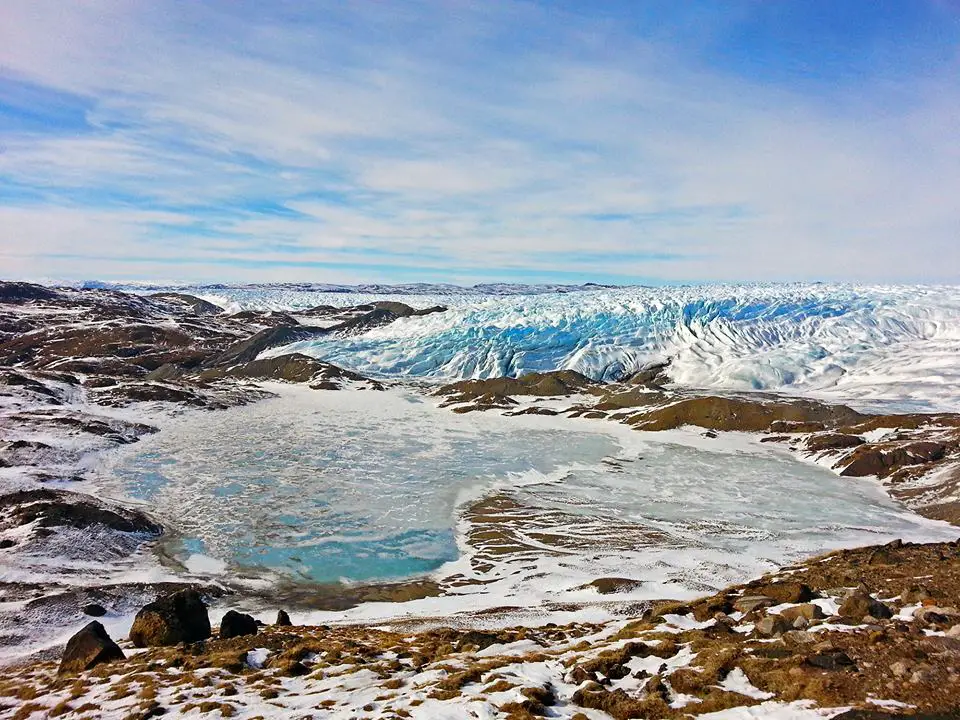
249,285,960,410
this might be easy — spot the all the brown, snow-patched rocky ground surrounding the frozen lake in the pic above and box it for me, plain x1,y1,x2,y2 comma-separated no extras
0,283,960,720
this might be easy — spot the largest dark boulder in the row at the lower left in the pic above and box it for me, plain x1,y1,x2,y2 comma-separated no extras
130,590,210,647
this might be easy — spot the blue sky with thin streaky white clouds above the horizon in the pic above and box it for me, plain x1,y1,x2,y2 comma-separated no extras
0,0,960,284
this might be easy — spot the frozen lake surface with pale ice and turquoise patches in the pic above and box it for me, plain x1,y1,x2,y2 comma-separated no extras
105,387,956,597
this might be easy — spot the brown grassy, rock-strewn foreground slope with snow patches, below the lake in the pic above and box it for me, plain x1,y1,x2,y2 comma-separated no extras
0,541,960,720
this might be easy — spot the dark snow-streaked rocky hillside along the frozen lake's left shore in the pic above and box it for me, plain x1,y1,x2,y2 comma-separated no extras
0,283,442,668
